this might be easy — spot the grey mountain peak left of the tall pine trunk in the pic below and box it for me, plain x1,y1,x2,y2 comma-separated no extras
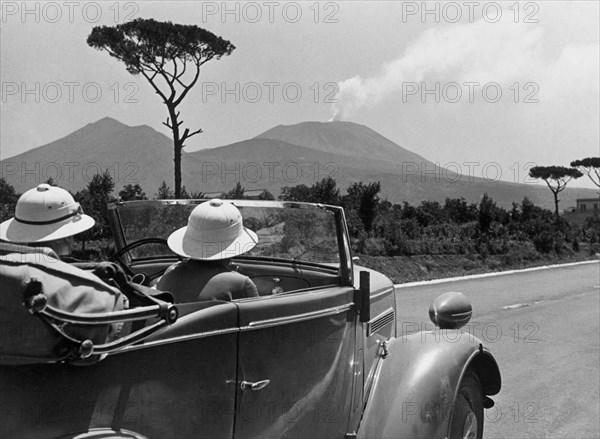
1,117,178,192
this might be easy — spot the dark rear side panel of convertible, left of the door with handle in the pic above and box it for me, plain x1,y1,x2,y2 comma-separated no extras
0,302,239,439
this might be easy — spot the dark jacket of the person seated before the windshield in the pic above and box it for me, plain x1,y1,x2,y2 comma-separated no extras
157,260,258,303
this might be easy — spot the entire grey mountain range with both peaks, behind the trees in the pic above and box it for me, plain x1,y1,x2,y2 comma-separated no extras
0,118,596,209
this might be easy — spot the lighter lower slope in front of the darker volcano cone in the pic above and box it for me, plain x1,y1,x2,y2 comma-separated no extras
184,137,594,209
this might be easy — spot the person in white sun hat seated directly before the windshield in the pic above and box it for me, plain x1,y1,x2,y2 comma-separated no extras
157,199,258,303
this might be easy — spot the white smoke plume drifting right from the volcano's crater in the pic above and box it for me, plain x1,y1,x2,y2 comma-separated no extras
332,20,599,119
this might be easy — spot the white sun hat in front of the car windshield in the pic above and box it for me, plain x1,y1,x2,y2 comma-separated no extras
167,199,258,261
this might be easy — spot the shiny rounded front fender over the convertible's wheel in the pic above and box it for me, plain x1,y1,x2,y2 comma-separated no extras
357,329,501,439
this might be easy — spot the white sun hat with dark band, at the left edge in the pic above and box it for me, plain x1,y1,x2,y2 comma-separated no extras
0,184,95,244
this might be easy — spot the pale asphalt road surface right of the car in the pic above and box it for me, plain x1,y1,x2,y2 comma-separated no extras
397,263,600,438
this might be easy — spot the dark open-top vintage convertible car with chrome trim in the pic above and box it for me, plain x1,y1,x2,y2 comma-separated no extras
0,200,501,439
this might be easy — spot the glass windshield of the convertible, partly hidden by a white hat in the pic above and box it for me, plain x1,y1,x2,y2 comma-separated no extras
110,200,340,267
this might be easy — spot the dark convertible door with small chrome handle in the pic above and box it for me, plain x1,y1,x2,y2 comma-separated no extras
234,287,362,438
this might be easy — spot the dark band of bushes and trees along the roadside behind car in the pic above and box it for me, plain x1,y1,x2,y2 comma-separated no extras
0,172,600,283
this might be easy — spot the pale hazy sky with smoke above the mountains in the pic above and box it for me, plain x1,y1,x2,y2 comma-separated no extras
0,1,600,187
